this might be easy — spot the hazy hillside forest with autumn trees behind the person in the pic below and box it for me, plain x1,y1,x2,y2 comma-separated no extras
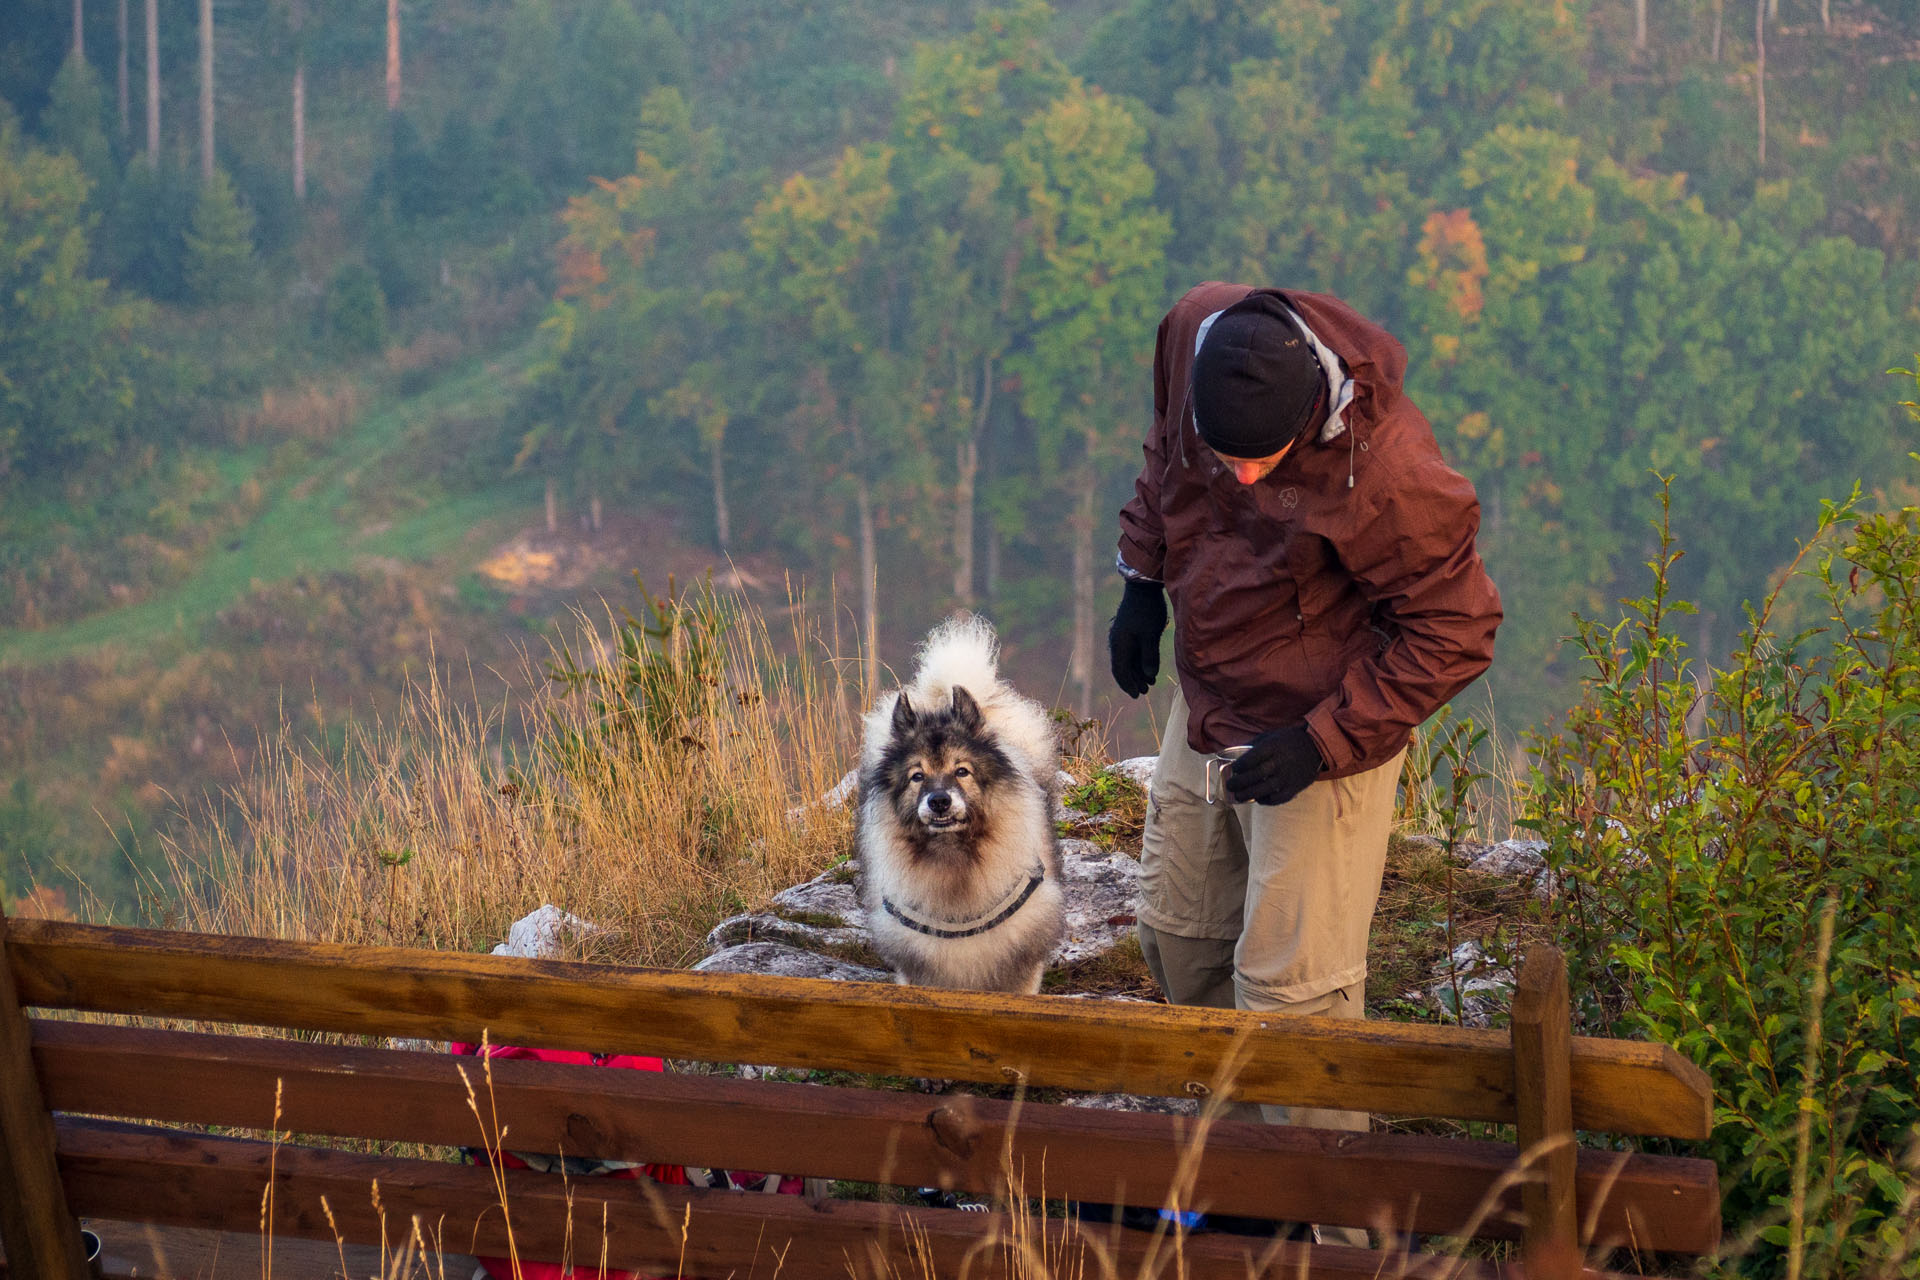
0,0,1920,908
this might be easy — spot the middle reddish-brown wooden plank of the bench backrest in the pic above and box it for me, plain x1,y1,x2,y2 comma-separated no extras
35,1019,1718,1253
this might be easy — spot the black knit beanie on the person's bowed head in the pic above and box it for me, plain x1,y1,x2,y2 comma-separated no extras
1192,294,1327,459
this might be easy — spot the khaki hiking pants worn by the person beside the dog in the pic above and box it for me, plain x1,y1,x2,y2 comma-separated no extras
1139,693,1405,1245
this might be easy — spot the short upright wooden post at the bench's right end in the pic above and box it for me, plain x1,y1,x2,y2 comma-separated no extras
1513,944,1580,1280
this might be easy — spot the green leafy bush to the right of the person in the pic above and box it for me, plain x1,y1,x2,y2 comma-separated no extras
1524,466,1920,1276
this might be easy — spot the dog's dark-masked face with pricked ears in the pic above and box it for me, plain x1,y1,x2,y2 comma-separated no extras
879,687,1012,856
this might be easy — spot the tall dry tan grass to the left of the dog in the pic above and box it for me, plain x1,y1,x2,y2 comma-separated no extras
156,593,864,965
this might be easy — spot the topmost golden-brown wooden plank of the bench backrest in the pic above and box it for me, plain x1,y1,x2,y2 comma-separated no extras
10,921,1709,1138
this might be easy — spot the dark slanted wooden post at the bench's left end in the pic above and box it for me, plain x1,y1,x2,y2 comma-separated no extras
0,912,88,1280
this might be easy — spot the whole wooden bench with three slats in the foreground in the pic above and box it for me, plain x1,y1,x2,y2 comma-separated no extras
0,919,1720,1280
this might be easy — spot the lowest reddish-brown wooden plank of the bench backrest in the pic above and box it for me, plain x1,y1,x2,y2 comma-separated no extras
60,1119,1507,1280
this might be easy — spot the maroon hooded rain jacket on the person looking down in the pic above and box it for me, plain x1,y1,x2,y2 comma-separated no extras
1119,282,1500,777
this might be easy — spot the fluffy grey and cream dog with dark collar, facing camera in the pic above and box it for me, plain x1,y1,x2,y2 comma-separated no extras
856,614,1066,992
